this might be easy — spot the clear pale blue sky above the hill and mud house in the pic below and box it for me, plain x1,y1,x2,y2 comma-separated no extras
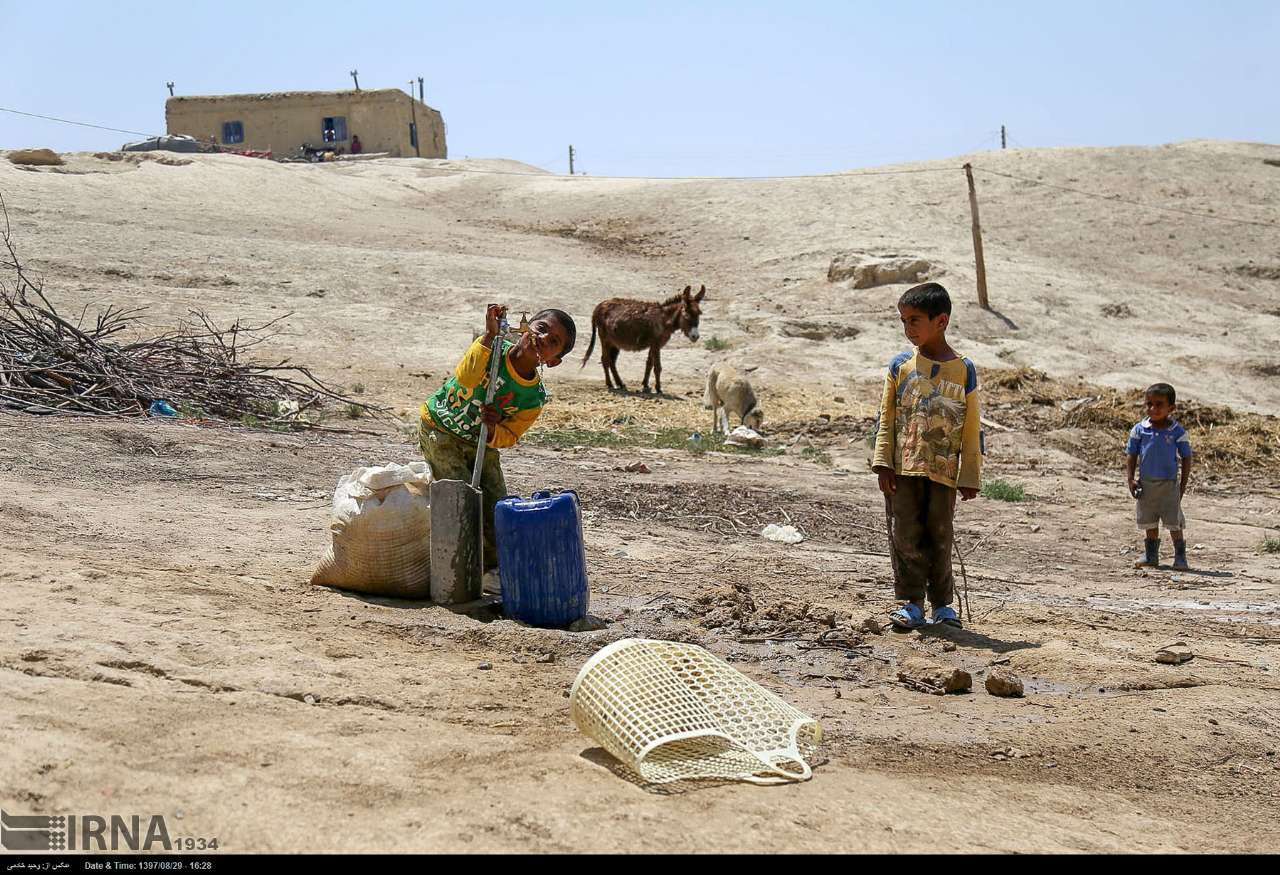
0,0,1280,175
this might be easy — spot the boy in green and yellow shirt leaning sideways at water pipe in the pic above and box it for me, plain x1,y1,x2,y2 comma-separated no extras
419,304,577,571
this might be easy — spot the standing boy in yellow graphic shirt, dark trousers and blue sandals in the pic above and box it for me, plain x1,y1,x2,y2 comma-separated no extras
872,283,983,629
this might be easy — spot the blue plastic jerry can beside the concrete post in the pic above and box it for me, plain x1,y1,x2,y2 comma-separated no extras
494,491,590,627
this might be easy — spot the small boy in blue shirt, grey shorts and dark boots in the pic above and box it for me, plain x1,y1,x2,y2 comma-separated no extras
1125,382,1192,571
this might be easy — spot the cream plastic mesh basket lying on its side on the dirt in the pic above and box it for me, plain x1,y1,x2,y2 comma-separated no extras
570,638,822,784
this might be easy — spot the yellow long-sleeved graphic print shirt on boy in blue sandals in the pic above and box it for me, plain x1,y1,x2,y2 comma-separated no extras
872,351,983,489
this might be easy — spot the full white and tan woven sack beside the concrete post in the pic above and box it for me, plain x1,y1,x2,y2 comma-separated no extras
311,462,431,599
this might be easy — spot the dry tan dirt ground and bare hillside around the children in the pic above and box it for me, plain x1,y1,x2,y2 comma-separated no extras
0,143,1280,852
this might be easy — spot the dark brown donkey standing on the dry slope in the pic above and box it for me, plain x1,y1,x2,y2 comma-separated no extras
582,285,707,395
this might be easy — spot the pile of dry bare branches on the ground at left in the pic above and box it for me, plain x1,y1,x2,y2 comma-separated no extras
0,197,384,429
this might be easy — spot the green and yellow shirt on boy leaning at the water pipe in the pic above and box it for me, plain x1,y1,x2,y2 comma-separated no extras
421,338,547,449
